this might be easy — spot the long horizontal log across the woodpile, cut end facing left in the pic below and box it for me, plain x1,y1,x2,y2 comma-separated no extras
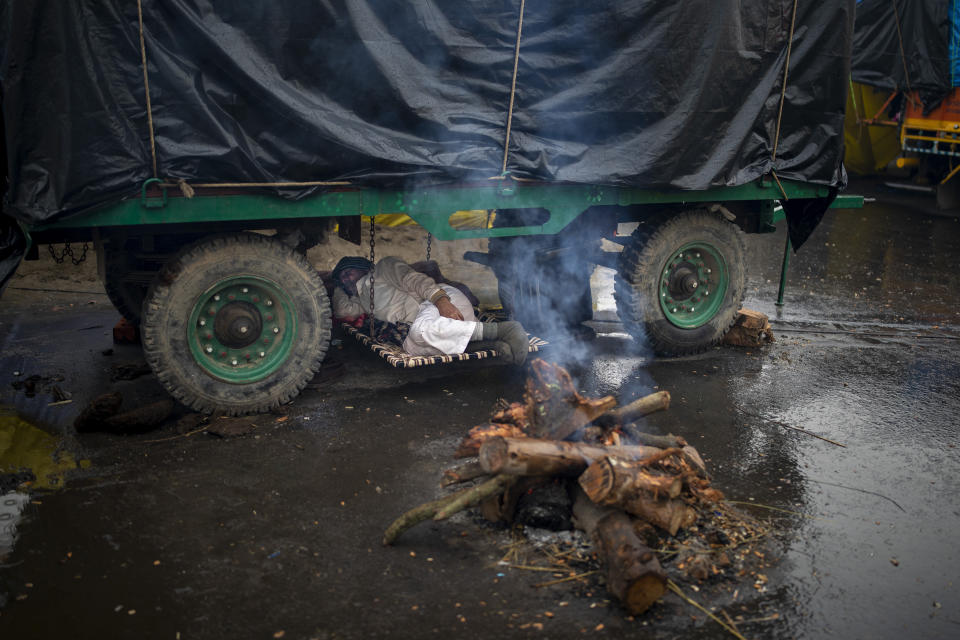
480,437,661,476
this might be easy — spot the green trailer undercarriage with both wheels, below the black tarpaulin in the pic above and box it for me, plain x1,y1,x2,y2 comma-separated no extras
24,176,863,415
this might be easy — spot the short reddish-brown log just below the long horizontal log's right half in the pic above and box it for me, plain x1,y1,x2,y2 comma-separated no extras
579,456,684,504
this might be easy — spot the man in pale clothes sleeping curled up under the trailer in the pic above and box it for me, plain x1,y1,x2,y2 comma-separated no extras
332,256,530,365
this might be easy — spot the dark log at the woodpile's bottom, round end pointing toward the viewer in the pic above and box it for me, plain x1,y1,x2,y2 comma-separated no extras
573,490,667,615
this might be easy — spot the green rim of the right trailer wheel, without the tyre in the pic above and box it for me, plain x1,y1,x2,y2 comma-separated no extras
659,242,730,329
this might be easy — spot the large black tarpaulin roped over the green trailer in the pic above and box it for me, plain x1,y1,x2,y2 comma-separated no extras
0,0,854,290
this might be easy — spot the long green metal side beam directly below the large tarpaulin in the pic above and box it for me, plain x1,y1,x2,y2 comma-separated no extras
33,179,862,240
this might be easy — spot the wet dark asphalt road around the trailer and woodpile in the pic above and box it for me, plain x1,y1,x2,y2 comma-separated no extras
0,184,960,640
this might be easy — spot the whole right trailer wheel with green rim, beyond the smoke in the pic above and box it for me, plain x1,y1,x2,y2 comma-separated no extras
615,210,746,355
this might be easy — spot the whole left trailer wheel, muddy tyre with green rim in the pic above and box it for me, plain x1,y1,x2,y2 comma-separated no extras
141,233,331,415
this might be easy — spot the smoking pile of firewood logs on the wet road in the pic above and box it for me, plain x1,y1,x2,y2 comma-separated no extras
383,360,722,614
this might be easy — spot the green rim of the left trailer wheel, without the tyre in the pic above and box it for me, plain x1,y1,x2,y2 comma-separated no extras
187,276,297,384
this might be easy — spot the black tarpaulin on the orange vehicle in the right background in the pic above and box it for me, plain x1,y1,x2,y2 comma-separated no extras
852,0,958,106
